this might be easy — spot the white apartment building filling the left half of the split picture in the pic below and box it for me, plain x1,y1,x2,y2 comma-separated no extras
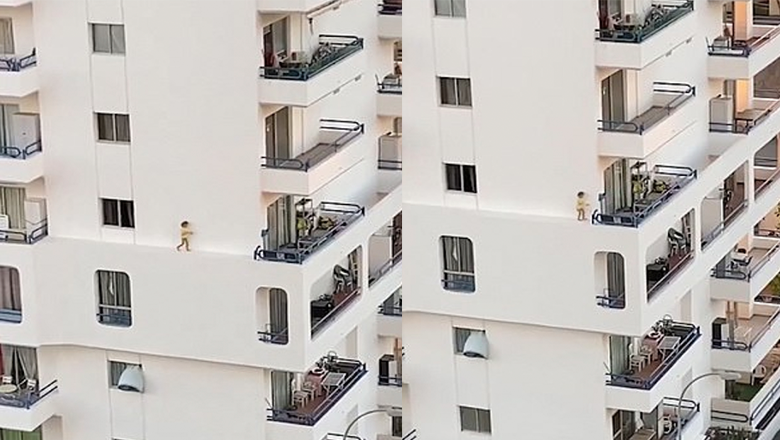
0,0,402,440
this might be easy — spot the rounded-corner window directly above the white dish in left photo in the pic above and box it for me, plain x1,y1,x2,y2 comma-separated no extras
96,270,133,327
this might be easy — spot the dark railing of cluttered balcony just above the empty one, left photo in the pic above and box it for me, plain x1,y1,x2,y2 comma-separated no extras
260,34,363,81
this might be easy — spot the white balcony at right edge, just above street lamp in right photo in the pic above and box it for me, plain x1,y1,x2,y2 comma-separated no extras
712,304,780,371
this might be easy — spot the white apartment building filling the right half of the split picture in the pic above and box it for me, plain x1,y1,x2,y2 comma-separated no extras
403,0,780,440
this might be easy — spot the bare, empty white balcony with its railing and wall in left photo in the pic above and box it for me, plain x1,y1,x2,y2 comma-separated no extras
260,119,365,195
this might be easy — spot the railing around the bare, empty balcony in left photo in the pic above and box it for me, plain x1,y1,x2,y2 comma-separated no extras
262,119,365,171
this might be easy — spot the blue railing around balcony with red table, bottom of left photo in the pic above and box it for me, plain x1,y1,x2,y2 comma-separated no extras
268,359,367,426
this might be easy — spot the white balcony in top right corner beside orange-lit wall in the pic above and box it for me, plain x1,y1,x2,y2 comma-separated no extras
708,25,780,79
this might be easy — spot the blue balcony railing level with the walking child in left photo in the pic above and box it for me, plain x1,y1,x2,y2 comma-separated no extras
254,202,366,264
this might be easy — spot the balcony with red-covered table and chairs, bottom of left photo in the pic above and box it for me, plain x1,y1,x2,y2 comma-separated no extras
268,355,367,426
